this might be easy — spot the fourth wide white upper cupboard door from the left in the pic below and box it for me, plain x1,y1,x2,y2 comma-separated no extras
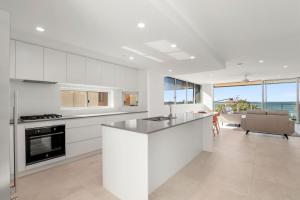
86,58,101,85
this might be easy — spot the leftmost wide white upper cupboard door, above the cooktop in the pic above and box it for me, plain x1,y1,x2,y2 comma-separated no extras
16,41,44,81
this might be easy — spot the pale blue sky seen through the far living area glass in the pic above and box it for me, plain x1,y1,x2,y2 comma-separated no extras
214,83,296,102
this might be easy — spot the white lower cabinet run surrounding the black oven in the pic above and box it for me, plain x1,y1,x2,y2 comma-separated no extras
10,112,147,175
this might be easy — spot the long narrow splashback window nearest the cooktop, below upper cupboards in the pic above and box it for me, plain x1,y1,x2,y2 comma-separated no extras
60,90,109,108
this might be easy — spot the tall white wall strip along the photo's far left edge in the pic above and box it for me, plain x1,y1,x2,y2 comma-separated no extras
0,10,10,200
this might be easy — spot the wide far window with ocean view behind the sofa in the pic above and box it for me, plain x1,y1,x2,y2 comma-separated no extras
214,79,299,120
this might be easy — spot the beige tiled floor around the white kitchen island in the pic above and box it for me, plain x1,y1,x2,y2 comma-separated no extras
18,129,300,200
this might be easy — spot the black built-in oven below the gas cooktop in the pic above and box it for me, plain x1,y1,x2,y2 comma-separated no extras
25,125,66,165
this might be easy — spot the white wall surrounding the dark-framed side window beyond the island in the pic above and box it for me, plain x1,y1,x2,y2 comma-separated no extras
147,71,213,116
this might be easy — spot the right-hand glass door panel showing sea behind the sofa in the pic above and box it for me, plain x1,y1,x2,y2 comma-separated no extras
264,79,297,120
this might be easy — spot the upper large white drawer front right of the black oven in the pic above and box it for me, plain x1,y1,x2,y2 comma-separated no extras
66,125,102,144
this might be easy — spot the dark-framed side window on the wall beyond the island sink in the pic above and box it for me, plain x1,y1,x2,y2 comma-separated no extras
164,77,201,104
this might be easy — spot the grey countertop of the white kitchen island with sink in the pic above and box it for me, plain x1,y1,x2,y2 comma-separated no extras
102,112,214,134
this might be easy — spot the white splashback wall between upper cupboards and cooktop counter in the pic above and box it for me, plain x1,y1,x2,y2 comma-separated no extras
10,70,147,118
